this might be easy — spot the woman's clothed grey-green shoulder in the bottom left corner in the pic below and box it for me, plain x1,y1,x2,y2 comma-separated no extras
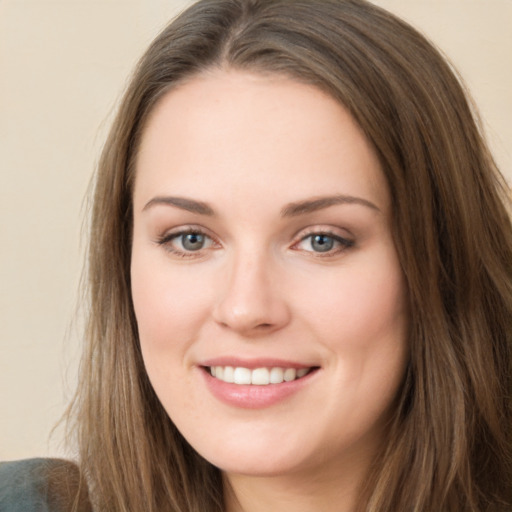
0,459,92,512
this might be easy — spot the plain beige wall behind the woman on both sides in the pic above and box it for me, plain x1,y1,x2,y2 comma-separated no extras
0,0,512,460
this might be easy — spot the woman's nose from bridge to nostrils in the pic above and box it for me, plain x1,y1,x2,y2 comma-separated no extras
213,251,290,337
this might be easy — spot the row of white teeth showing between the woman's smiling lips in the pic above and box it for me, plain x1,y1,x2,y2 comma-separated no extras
205,366,318,386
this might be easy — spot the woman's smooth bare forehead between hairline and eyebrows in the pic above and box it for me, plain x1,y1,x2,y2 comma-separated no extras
135,70,388,212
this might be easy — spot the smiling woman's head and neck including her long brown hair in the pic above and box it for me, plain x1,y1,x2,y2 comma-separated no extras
3,0,512,512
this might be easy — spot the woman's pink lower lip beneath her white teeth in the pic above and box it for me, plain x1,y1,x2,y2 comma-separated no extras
201,368,318,409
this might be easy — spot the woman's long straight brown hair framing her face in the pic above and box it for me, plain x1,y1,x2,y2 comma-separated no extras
70,0,512,512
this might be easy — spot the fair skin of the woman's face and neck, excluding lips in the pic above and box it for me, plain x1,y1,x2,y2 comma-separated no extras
131,69,407,512
